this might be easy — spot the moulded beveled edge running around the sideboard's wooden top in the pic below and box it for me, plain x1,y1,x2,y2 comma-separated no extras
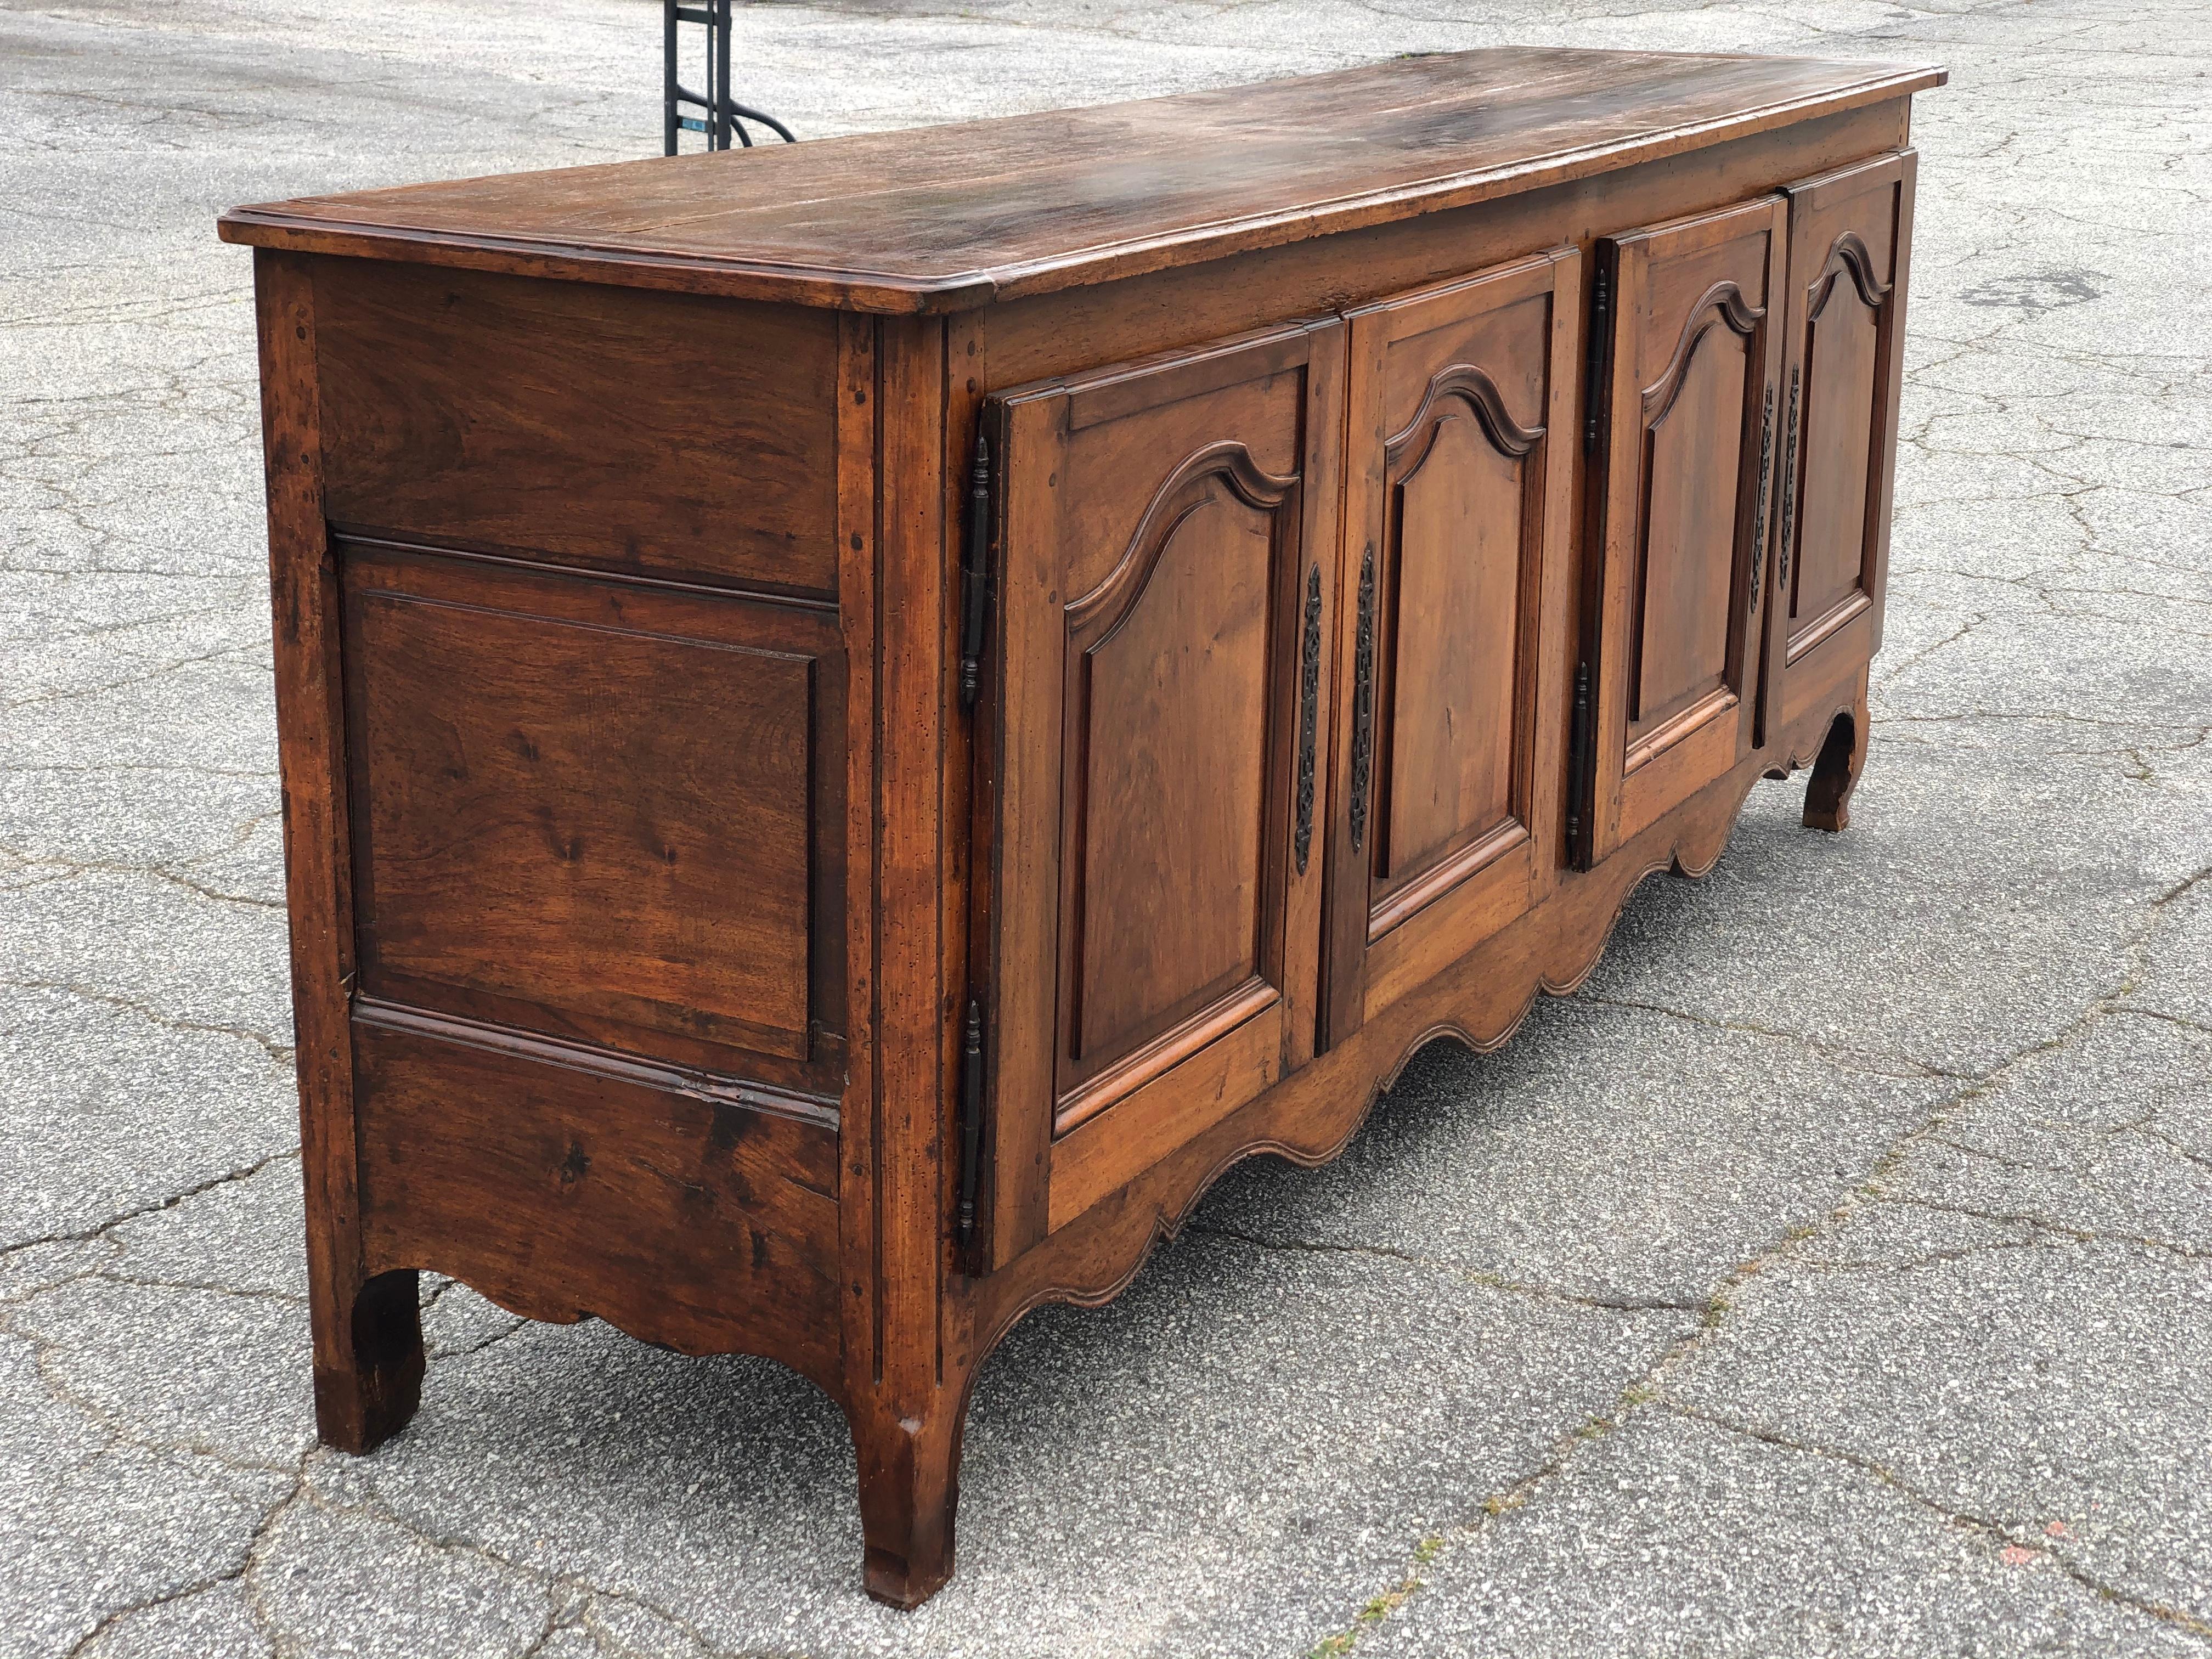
217,49,1951,314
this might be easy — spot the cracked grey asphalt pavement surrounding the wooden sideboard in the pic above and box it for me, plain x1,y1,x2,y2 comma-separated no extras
0,0,2212,1659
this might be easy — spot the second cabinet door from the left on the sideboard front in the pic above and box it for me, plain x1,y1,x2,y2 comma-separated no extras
1327,248,1582,1042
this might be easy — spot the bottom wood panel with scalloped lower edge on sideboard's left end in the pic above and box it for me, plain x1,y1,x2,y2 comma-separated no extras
354,1007,838,1383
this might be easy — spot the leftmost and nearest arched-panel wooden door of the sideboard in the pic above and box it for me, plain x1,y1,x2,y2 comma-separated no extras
986,321,1342,1261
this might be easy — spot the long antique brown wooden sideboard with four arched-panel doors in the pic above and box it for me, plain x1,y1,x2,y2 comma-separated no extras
221,51,1944,1606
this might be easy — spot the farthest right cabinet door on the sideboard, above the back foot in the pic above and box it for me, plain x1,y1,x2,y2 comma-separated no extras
1765,150,1916,723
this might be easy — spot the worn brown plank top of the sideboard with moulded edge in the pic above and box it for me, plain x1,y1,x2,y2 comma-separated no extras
221,47,1946,312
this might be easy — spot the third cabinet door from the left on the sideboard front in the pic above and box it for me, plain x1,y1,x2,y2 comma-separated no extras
1575,195,1785,860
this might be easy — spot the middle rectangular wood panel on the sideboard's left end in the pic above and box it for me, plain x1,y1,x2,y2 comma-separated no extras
343,544,843,1082
